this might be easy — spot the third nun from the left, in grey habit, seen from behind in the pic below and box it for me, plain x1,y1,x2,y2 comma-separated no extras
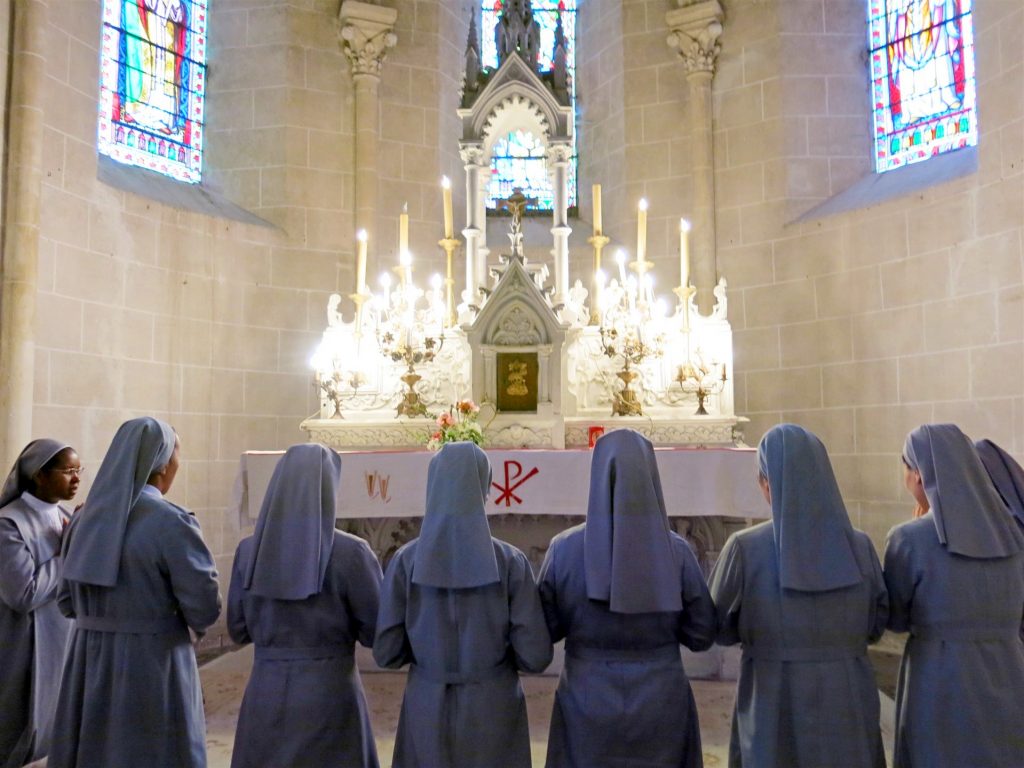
227,443,381,768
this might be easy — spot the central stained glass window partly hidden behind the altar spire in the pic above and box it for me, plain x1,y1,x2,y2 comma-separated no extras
480,0,577,211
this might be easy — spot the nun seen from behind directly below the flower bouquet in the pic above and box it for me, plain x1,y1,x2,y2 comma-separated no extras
374,442,552,768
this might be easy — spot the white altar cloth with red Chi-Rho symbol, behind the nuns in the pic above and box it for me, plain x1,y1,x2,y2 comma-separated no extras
234,447,770,521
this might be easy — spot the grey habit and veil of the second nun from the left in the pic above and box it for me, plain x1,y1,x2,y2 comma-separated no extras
49,418,220,768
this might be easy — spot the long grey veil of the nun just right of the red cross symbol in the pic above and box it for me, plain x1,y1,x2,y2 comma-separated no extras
584,429,683,613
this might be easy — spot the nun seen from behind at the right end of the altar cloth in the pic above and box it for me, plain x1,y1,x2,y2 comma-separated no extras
711,424,889,768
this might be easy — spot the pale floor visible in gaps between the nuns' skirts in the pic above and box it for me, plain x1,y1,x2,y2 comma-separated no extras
201,646,892,768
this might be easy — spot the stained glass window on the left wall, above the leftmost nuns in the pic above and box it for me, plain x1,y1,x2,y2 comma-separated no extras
97,0,207,183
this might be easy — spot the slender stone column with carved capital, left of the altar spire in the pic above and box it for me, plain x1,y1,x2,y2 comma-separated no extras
339,0,398,274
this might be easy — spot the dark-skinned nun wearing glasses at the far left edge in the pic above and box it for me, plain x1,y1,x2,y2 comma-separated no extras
0,439,82,768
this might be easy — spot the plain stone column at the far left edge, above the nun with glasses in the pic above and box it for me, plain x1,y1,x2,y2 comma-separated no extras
0,0,47,467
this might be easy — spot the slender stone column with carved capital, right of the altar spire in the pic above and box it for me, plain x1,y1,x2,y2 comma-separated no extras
665,0,725,314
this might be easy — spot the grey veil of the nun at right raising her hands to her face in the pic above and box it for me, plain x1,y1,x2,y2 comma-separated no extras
903,424,1024,558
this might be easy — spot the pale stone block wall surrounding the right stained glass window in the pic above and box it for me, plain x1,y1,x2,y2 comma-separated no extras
716,0,1024,545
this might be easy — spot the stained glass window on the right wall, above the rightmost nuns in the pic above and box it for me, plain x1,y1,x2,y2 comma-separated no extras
867,0,978,173
